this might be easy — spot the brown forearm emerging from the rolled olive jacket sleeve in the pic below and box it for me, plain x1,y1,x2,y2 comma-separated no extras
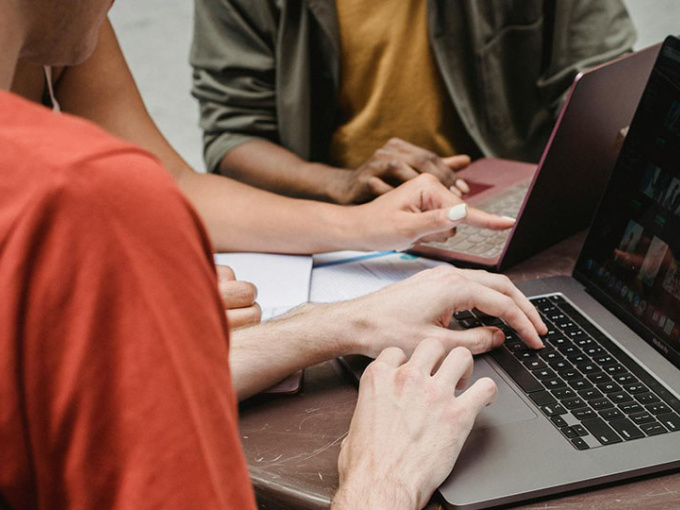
220,139,354,203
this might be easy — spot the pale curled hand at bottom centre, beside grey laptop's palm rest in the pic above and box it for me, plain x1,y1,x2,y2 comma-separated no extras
331,340,497,510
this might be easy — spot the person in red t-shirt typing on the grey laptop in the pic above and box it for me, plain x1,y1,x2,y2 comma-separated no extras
0,0,545,510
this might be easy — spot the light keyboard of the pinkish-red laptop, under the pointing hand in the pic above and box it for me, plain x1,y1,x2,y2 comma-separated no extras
427,180,531,258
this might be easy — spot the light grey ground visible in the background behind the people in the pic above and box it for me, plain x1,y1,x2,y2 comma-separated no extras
111,0,680,170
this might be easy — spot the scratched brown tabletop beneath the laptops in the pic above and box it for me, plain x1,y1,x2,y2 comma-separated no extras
240,235,680,510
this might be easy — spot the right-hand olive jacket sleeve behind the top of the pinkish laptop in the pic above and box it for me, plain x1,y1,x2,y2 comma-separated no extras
538,0,637,114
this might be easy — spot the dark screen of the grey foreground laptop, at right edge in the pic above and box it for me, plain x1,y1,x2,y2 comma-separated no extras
574,37,680,370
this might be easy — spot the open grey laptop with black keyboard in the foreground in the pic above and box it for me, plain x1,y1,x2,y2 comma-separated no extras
344,37,680,509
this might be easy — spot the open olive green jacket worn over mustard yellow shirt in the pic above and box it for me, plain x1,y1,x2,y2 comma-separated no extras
191,0,635,171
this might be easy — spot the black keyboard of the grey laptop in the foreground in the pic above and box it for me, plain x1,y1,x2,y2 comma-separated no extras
454,294,680,450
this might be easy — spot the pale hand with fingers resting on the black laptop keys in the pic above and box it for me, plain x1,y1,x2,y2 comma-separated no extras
338,266,547,357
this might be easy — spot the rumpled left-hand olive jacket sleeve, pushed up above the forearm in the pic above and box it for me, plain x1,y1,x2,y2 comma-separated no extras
190,0,278,172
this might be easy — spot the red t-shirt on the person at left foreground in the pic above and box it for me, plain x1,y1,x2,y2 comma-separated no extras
0,92,255,510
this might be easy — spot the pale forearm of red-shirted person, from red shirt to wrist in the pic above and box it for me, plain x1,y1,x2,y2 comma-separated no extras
229,303,368,400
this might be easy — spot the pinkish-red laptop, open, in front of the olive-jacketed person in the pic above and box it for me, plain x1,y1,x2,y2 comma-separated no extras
411,45,659,270
